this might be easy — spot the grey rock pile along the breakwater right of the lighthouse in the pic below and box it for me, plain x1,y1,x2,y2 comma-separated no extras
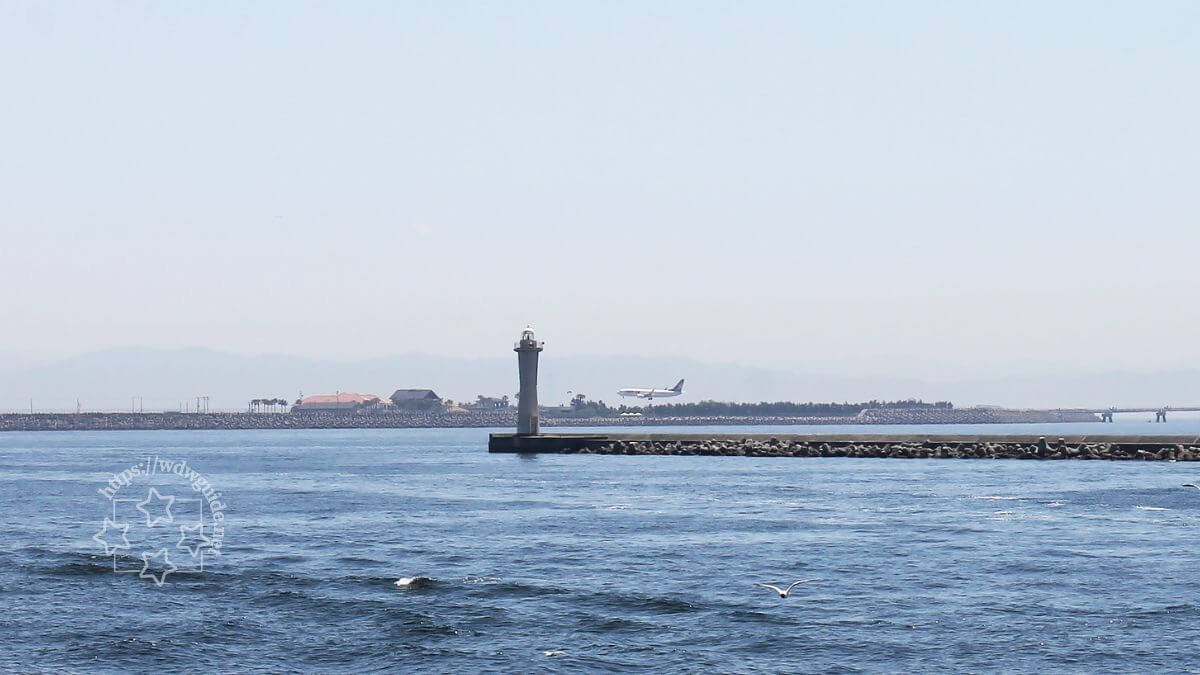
578,438,1200,461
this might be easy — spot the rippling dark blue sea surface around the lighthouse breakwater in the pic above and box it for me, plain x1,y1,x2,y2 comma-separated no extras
0,420,1200,673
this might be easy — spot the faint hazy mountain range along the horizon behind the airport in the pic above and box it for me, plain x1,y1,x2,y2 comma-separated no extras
0,347,1200,411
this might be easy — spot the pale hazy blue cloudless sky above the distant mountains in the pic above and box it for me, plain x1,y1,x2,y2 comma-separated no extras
0,0,1200,378
